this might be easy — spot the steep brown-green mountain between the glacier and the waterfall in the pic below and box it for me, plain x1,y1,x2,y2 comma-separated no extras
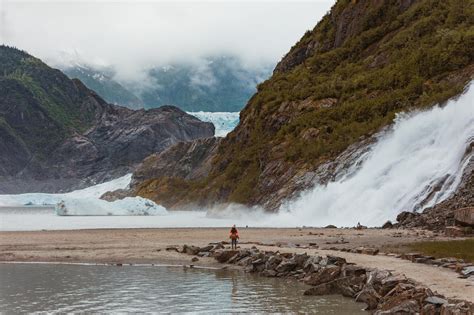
126,0,474,210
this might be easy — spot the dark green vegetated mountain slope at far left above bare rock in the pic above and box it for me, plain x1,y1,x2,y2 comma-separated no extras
0,45,103,168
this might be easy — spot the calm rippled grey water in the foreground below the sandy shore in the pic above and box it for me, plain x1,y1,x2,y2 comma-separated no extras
0,264,367,314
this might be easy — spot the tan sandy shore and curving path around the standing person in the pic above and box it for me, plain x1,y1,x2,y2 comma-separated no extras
0,228,474,301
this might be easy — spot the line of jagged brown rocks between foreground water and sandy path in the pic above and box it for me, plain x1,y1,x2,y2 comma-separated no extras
181,243,474,315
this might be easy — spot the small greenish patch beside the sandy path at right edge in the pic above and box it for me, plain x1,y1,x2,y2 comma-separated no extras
407,238,474,263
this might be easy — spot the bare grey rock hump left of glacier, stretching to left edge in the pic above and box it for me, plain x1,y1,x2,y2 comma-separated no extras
0,105,214,193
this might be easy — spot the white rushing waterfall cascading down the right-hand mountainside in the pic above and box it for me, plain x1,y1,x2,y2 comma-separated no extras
275,83,474,226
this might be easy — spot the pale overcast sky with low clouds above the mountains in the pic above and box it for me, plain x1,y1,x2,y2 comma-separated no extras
0,0,334,81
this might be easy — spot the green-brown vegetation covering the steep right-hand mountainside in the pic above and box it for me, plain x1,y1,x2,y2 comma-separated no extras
206,0,474,203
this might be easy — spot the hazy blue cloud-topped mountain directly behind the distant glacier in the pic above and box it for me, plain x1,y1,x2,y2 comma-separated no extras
135,56,271,112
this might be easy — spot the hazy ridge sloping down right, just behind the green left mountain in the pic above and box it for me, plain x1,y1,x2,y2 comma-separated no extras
63,64,144,109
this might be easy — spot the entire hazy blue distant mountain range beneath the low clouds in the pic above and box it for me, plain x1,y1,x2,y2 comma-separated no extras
63,56,271,112
